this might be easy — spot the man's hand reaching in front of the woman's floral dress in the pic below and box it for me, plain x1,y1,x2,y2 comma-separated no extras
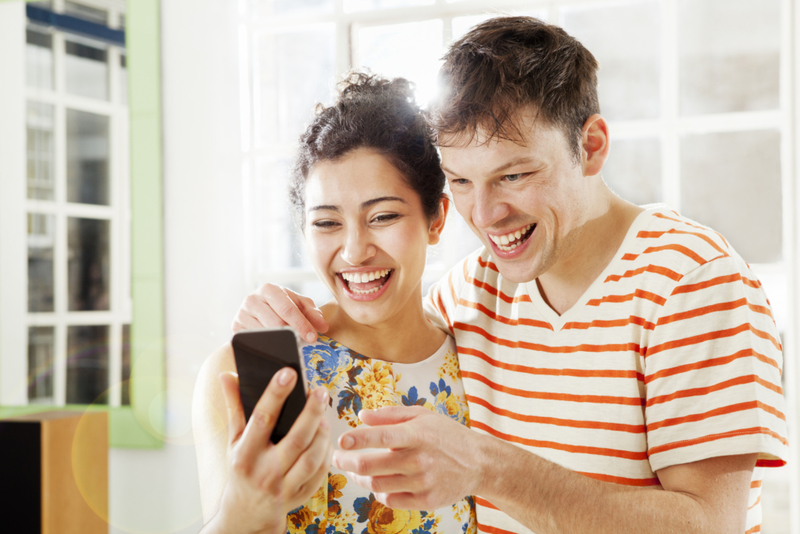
334,406,480,510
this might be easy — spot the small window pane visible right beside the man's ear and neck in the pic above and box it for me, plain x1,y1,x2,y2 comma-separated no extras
603,139,663,206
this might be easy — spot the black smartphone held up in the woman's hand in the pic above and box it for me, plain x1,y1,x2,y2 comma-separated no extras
231,327,306,443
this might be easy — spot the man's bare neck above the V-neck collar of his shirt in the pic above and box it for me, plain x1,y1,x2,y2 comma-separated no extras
536,191,642,315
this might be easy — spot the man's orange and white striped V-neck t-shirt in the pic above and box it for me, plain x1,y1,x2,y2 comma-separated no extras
425,207,788,533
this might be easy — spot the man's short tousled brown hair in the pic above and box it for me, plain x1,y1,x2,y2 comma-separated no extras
430,17,600,161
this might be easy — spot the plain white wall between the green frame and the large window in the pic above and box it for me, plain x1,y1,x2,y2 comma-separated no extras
109,0,247,534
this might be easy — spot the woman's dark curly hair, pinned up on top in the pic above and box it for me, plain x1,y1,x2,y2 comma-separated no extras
289,71,445,227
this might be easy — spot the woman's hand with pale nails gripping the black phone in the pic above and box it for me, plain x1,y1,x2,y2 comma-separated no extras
204,368,333,533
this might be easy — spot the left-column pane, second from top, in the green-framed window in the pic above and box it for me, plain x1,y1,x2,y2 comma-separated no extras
26,102,55,200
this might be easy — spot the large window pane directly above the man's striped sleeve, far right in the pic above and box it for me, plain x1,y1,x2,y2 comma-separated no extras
681,131,783,263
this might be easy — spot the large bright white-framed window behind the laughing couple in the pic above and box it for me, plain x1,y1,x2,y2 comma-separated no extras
240,0,800,532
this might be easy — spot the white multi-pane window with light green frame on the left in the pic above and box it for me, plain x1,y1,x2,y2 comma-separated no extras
0,0,164,447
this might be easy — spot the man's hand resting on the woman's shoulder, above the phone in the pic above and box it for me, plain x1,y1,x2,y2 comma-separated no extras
232,284,328,343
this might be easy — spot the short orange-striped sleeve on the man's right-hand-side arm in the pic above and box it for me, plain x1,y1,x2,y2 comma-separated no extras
644,256,788,471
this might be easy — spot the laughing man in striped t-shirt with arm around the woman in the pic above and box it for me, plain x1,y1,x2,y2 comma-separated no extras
234,17,787,534
